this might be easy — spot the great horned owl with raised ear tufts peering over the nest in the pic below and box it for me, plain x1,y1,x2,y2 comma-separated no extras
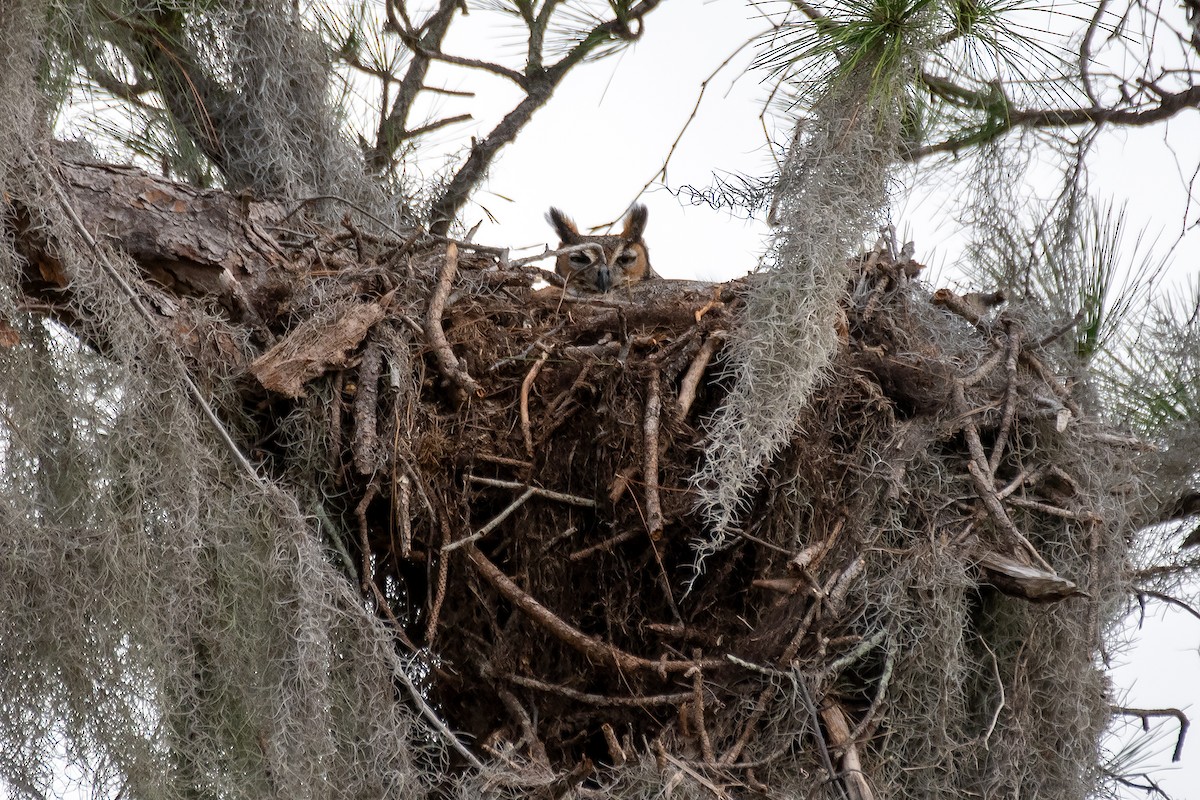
546,205,659,291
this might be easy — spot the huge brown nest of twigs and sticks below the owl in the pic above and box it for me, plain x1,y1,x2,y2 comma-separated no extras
208,215,1128,798
